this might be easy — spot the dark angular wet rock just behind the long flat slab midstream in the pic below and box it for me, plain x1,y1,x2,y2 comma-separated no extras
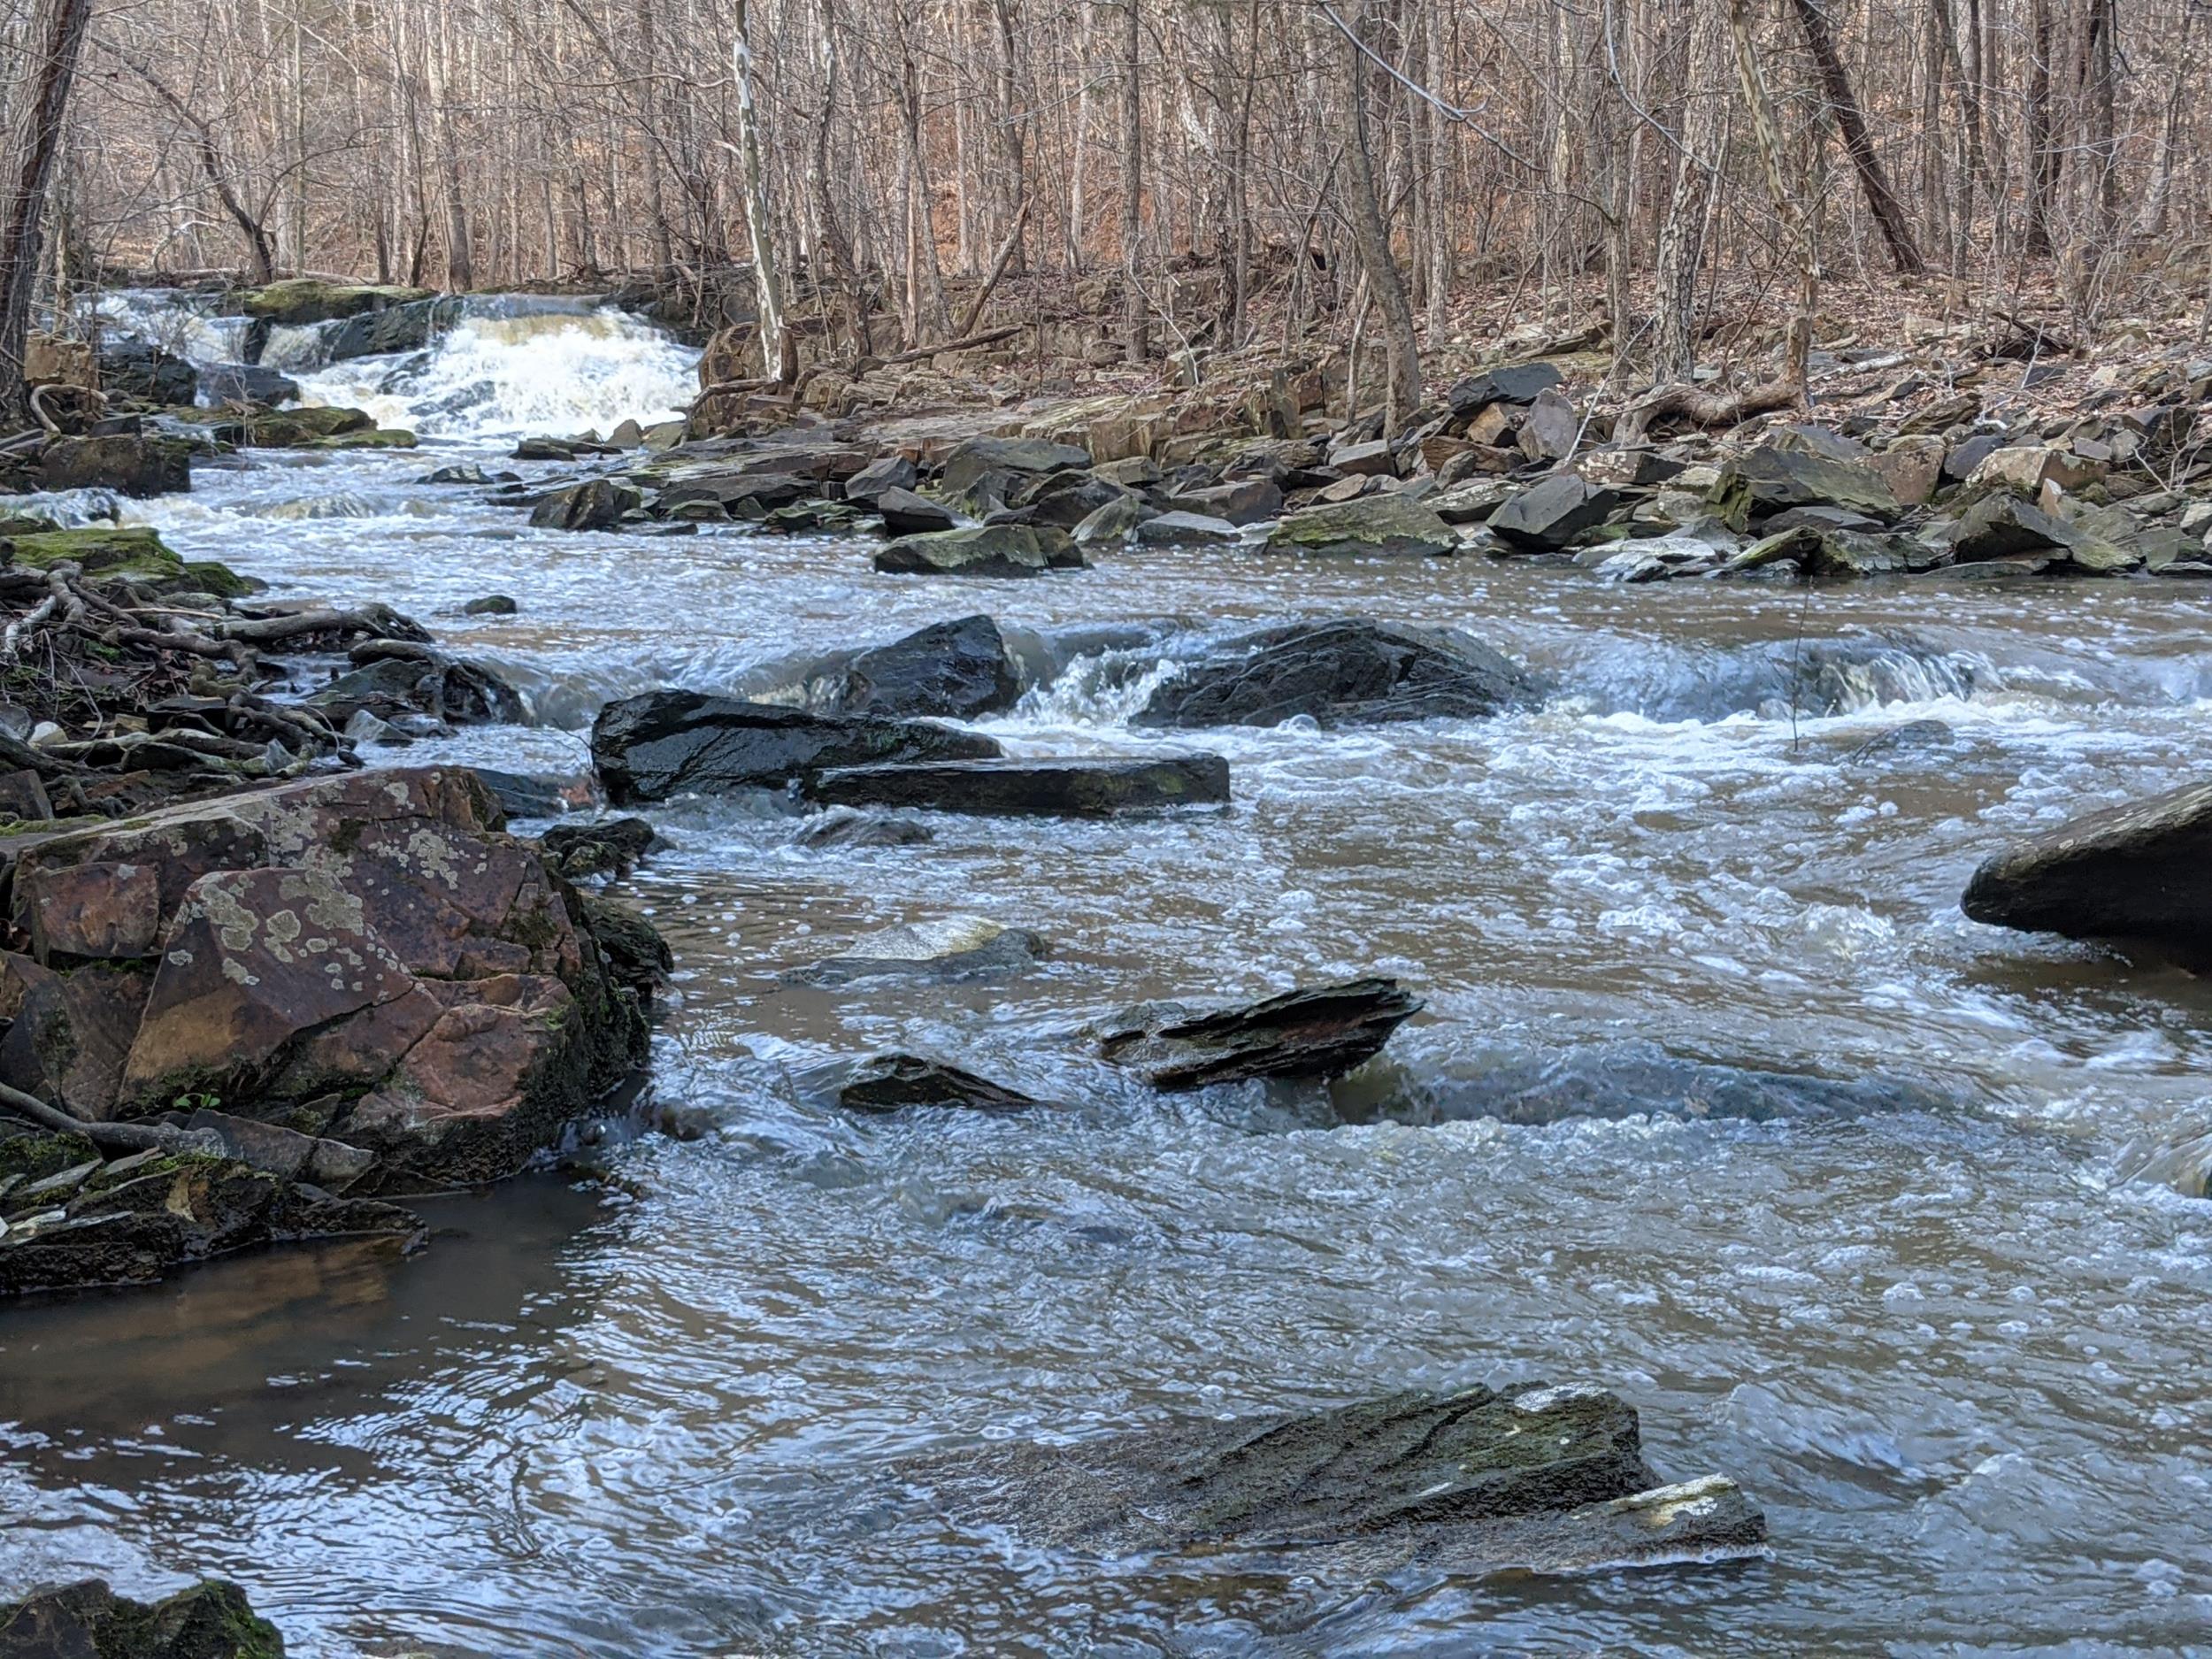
591,690,1000,805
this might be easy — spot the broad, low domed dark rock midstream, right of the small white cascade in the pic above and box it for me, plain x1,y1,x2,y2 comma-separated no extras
1131,618,1544,726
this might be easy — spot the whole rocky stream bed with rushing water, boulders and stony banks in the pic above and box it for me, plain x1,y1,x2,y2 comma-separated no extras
0,299,2212,1659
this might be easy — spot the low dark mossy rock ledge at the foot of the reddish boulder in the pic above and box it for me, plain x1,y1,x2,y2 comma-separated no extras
0,1113,423,1301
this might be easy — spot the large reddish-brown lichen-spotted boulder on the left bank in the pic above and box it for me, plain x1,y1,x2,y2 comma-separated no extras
0,768,644,1181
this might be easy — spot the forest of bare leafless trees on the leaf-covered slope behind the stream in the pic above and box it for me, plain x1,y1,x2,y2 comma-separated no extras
4,0,2212,409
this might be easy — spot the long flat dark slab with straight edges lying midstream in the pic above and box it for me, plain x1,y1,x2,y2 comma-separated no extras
803,755,1230,818
